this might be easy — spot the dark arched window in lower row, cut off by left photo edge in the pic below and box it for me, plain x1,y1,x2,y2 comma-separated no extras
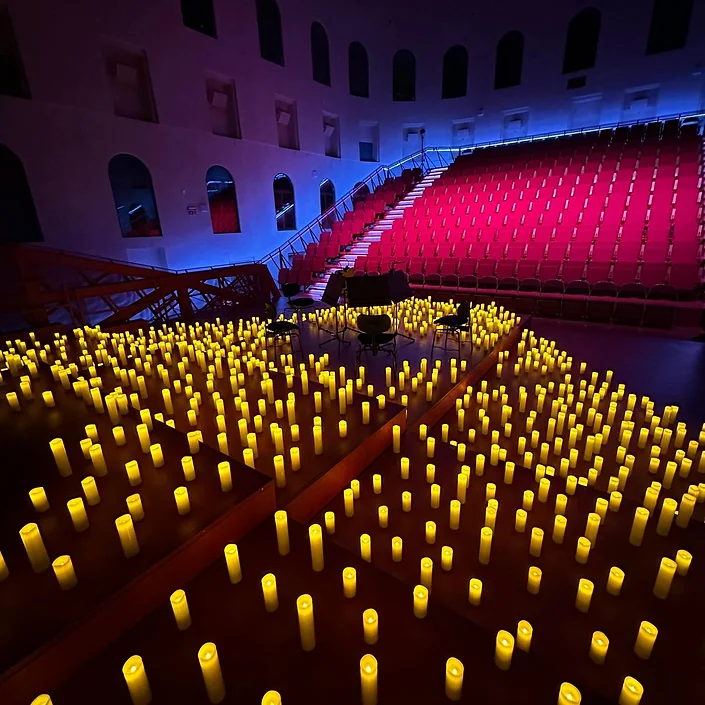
0,145,44,243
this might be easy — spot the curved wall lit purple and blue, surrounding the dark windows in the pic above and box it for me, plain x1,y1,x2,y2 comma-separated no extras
0,0,705,268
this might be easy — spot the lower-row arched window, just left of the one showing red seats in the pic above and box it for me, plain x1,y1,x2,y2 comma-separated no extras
108,154,162,237
